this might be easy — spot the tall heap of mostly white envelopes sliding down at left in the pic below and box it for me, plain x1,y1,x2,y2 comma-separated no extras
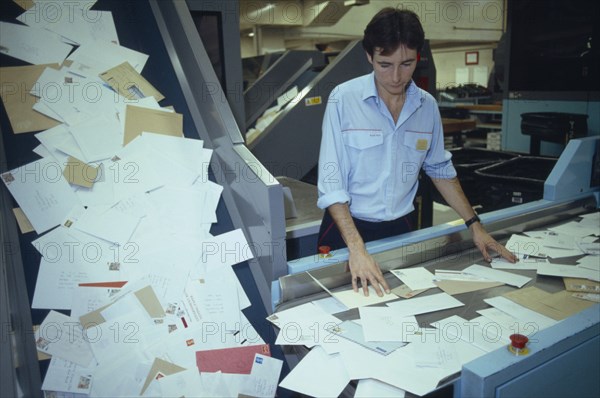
0,1,282,397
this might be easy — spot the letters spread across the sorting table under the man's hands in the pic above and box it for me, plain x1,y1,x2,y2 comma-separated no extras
267,212,600,397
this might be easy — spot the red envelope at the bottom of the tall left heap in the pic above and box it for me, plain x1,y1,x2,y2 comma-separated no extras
196,344,271,374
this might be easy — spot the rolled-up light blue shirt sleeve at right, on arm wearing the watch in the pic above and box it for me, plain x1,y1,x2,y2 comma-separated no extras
423,97,456,179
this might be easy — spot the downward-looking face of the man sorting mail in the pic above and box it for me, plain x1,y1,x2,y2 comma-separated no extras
367,45,417,96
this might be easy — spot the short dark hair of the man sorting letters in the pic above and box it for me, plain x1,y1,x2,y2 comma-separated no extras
362,7,425,56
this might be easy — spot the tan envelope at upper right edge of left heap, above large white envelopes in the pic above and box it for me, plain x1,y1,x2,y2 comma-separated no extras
123,105,183,145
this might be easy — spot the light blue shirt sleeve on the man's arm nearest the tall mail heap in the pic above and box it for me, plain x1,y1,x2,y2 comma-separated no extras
317,90,350,209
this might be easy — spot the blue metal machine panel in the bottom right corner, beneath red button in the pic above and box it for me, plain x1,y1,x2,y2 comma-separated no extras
460,305,600,398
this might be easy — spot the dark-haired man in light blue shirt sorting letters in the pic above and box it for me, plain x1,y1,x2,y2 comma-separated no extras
317,8,516,295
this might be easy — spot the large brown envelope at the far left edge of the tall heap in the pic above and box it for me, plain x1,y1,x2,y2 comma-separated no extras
0,64,60,134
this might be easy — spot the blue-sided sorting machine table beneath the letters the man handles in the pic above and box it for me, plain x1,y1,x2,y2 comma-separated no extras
271,136,600,397
